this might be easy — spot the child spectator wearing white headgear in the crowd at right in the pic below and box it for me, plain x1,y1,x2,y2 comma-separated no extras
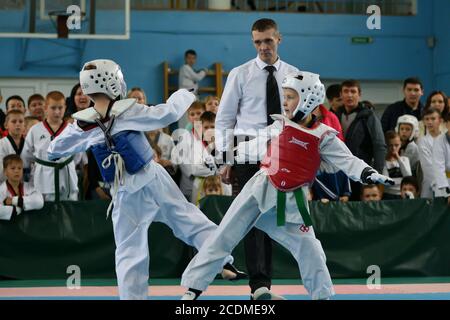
395,114,419,175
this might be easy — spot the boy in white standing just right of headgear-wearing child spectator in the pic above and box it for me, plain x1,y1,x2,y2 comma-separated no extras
417,107,442,198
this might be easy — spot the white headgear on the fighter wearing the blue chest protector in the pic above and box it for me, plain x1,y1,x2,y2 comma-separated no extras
80,59,127,100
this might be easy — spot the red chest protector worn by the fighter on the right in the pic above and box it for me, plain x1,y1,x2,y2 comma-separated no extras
261,120,328,192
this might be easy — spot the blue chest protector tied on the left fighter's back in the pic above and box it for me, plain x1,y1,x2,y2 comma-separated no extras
91,128,153,183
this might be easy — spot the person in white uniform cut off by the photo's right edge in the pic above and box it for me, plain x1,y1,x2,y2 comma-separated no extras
433,113,450,205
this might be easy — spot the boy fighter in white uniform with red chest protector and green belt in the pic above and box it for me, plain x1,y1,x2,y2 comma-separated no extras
181,72,393,300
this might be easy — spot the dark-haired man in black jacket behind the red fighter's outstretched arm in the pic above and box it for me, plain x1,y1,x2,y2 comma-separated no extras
337,80,386,200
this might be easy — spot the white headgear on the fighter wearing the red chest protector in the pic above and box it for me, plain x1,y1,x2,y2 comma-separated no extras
281,71,325,120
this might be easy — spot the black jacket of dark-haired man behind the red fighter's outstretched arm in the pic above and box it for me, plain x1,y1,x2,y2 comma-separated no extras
337,104,386,173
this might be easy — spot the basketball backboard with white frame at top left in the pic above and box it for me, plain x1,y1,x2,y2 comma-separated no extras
0,0,130,40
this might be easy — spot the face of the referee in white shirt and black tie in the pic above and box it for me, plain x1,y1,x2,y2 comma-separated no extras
252,28,281,65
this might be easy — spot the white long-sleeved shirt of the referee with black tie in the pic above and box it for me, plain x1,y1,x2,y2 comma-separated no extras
215,56,298,152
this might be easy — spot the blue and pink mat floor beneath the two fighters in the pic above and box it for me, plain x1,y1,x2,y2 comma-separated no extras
0,277,450,300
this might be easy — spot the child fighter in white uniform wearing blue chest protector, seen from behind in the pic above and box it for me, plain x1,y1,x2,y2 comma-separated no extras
48,60,242,299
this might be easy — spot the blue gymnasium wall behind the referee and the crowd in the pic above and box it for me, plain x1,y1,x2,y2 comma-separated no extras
0,0,444,102
